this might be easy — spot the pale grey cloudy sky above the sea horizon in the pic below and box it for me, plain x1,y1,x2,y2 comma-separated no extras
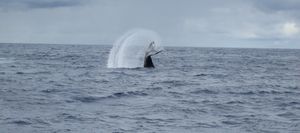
0,0,300,49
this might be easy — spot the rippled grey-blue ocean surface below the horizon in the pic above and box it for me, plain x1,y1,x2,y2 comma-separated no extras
0,44,300,133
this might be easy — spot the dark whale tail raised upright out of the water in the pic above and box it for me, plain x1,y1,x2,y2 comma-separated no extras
144,41,161,68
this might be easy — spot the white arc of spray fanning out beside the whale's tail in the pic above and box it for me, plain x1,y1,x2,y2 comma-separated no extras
107,29,163,68
